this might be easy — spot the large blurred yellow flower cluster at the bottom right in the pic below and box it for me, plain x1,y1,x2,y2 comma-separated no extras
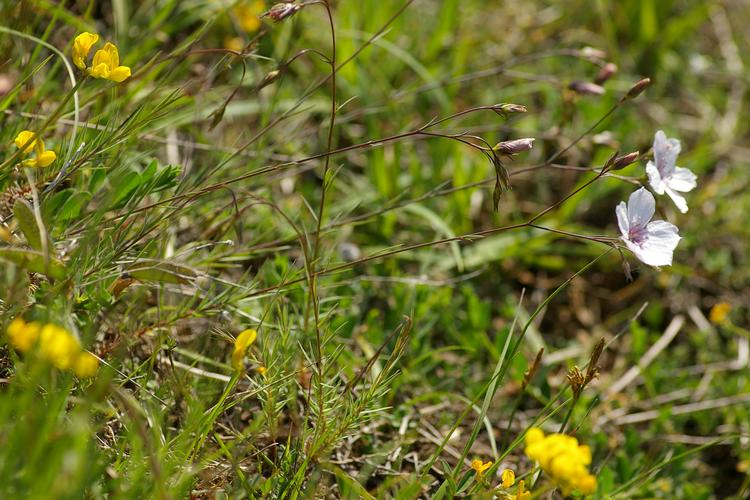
525,428,596,495
